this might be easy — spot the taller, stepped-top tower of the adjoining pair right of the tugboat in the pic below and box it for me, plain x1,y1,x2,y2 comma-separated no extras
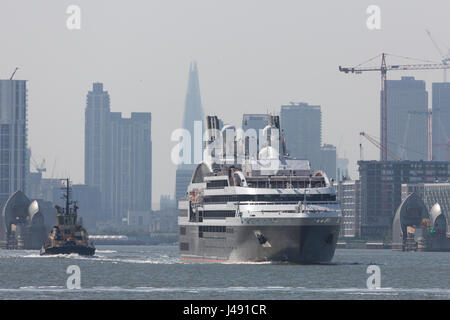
84,83,111,220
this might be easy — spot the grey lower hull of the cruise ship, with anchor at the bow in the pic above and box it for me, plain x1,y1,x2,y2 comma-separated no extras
180,225,339,264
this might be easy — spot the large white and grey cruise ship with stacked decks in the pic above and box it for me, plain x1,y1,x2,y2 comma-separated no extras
178,116,341,264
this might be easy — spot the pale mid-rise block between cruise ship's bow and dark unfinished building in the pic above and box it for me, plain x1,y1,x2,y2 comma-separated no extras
336,180,361,238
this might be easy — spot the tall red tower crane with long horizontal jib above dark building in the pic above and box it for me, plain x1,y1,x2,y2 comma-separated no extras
339,53,450,161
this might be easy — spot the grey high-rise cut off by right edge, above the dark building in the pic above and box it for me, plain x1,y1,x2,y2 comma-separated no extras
432,82,450,161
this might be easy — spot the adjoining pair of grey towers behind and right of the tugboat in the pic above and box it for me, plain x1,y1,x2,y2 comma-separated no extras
85,83,152,223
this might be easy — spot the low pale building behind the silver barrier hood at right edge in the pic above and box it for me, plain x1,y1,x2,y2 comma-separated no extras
402,182,450,233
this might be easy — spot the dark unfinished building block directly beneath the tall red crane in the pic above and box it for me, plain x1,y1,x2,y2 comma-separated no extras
358,161,450,240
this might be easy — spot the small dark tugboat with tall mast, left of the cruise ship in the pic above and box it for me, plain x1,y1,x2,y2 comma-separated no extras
40,179,95,256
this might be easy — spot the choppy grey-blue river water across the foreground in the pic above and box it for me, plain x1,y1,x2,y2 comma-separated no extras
0,246,450,300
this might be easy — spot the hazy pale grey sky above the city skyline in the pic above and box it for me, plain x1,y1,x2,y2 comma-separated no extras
0,0,450,208
